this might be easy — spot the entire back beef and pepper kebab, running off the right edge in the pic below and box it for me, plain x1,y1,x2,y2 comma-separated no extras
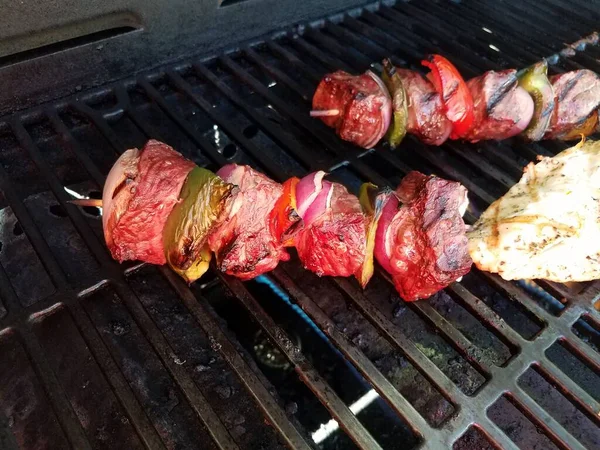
311,55,600,148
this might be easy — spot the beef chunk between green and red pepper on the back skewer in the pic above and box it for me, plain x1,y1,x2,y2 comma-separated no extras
396,68,452,145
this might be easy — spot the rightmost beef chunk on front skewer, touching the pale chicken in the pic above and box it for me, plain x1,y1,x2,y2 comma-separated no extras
375,172,472,301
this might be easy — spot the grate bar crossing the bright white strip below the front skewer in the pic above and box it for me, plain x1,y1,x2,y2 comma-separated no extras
219,274,381,449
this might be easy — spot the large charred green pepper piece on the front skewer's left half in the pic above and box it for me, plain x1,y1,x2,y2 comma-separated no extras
163,167,234,283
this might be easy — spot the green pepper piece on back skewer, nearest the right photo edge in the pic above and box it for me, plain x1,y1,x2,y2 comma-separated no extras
518,60,555,141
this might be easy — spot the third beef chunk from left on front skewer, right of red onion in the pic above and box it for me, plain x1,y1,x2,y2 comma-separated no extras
294,183,367,277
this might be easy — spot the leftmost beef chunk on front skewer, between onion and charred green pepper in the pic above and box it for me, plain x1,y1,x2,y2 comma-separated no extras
108,140,194,264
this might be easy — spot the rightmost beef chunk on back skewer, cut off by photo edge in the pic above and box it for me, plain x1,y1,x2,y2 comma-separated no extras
544,69,600,141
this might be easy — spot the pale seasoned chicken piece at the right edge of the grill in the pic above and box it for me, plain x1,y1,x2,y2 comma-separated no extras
468,141,600,282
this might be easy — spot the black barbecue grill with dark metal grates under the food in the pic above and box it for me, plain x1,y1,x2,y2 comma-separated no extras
0,0,600,449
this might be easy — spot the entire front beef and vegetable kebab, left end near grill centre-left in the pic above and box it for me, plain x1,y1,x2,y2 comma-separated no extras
75,140,472,301
